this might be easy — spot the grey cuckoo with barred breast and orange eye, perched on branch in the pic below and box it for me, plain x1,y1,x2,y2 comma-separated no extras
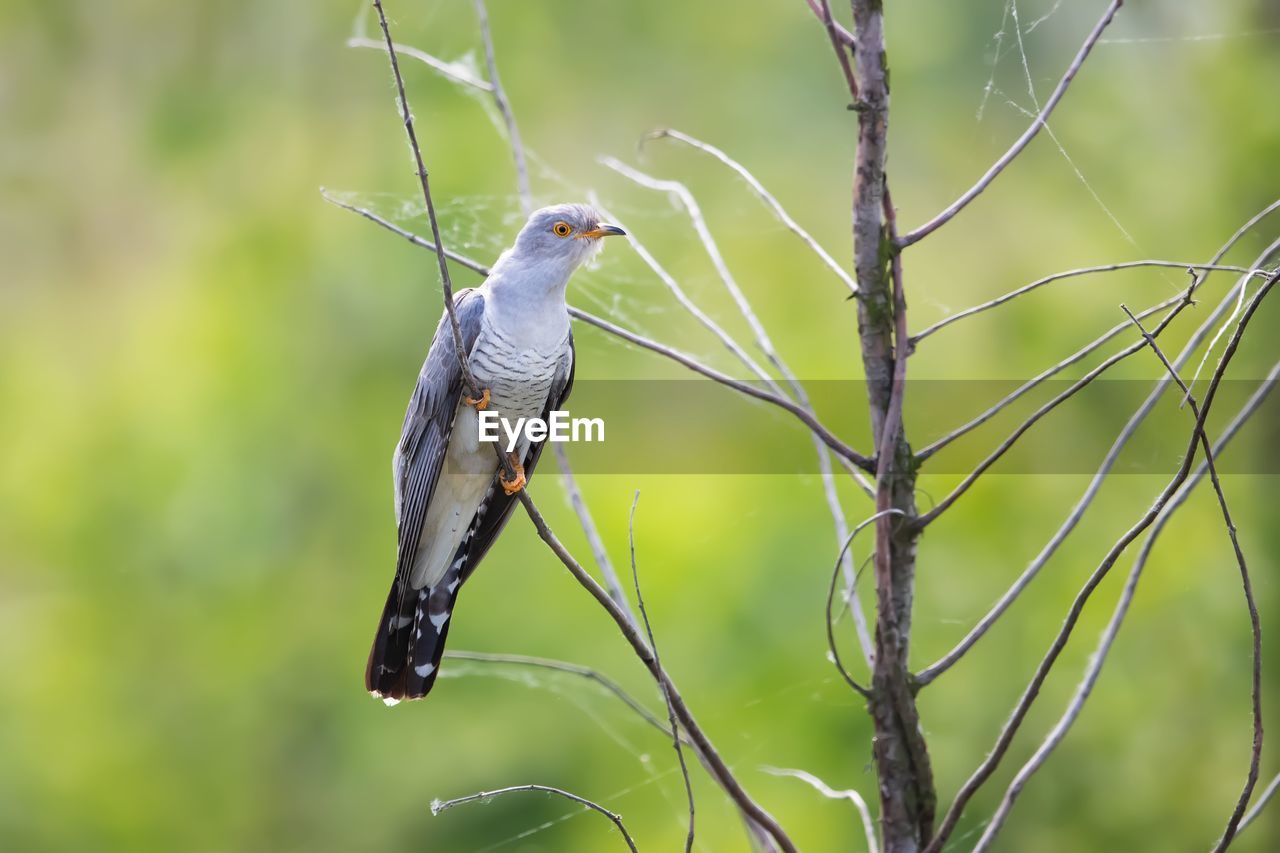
365,204,626,704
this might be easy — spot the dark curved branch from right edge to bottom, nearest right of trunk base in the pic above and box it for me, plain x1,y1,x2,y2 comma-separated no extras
925,267,1280,853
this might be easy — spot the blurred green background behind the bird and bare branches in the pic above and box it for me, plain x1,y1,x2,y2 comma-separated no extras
0,0,1280,850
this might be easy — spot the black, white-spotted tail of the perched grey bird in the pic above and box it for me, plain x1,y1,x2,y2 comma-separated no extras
365,556,465,704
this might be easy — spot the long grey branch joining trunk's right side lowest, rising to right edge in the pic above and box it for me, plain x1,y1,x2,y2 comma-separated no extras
916,234,1280,686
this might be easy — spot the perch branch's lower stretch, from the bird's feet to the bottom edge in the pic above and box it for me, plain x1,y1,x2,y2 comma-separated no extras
517,489,796,853
